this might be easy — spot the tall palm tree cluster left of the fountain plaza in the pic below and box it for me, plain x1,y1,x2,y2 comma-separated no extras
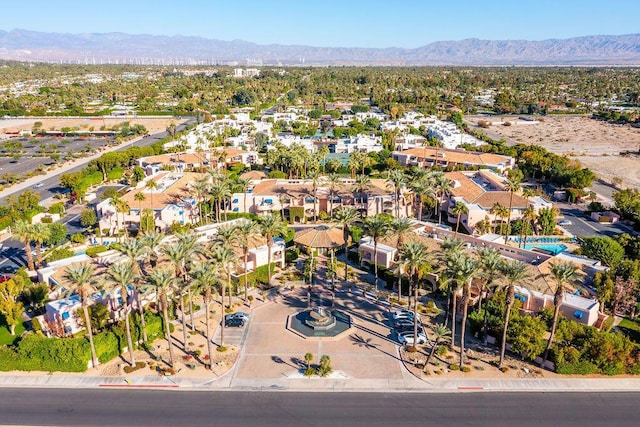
65,215,286,372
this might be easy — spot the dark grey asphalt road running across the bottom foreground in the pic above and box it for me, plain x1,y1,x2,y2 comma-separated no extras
0,392,638,427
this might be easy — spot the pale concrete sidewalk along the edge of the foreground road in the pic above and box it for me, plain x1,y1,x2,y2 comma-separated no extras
0,374,640,393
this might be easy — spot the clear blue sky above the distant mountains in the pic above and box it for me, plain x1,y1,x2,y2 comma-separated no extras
0,0,640,48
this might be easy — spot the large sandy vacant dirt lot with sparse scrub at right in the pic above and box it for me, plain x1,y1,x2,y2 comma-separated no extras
469,116,640,187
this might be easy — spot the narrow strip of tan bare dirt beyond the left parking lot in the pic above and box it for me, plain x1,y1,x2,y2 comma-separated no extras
0,117,183,135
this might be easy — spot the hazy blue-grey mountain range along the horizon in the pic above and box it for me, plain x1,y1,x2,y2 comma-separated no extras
0,29,640,66
